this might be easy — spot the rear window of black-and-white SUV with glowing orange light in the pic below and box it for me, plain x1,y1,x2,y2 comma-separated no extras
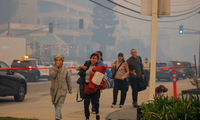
11,60,35,67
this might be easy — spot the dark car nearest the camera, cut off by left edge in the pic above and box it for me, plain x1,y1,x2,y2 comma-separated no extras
0,61,27,102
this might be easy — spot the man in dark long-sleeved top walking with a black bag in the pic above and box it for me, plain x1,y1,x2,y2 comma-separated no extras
127,49,144,107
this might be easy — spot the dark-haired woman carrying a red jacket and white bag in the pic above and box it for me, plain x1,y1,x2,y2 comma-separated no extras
76,53,100,120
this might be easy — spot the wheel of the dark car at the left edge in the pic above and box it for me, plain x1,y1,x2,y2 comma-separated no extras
14,84,25,102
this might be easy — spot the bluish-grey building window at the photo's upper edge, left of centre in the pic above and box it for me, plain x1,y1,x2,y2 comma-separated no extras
38,1,67,12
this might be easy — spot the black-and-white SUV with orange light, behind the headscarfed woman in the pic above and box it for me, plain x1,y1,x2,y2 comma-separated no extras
11,57,52,82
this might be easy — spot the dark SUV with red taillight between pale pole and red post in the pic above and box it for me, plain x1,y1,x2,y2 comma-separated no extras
156,61,179,81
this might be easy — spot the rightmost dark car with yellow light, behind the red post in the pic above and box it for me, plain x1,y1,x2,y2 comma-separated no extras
171,61,195,79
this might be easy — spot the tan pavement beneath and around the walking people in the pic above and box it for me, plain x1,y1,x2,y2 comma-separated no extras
0,75,195,120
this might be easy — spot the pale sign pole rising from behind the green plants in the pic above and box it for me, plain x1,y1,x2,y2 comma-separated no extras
149,0,158,100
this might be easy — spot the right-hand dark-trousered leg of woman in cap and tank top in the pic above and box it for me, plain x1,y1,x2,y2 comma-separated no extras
119,79,128,105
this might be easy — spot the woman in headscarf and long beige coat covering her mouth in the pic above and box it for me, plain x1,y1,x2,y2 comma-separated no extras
50,55,72,120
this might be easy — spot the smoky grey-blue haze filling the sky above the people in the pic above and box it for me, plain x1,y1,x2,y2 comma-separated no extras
0,0,200,62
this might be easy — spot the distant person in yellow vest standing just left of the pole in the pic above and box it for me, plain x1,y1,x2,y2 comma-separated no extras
143,58,150,86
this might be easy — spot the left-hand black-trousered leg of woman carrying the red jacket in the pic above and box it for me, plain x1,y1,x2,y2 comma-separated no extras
84,95,91,119
